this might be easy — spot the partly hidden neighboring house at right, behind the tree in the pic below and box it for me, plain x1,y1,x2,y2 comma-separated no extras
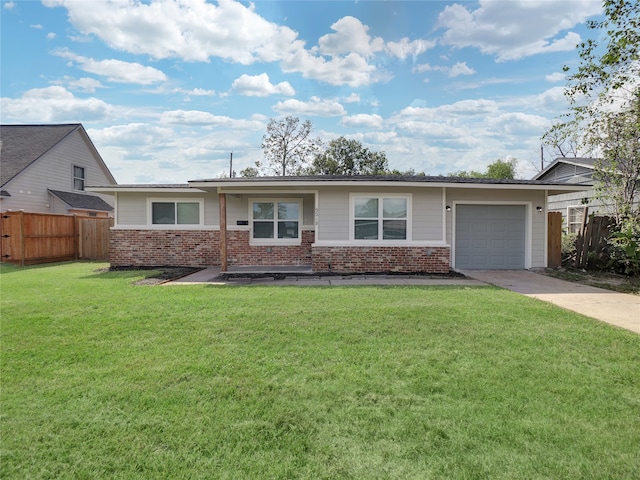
533,157,607,233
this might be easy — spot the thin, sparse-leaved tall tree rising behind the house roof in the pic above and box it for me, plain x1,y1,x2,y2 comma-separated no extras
260,116,320,176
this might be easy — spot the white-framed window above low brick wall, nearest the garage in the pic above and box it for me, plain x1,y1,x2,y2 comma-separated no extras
353,196,409,240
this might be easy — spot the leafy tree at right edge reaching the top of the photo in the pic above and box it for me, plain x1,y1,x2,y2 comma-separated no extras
546,0,640,220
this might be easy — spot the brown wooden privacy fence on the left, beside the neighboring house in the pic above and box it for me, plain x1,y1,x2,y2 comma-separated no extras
0,212,113,265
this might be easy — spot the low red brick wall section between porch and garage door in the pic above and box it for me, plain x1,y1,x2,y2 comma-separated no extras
313,246,450,273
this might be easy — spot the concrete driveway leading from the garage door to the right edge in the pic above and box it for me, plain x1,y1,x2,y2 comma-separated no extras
461,270,640,333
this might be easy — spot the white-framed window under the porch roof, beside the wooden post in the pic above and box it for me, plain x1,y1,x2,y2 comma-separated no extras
251,200,302,243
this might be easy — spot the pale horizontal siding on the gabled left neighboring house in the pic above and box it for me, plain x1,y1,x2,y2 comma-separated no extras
0,131,114,213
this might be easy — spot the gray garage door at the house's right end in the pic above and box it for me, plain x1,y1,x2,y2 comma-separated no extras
455,205,526,270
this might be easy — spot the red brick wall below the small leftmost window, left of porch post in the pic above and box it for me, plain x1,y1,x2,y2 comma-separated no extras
109,230,220,267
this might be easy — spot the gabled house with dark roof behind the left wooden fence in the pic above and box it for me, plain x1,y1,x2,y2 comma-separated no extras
0,124,116,217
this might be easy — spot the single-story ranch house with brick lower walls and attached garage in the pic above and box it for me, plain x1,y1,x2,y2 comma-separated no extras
90,176,590,273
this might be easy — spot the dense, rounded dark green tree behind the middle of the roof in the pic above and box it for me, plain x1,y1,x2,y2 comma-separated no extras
307,137,389,175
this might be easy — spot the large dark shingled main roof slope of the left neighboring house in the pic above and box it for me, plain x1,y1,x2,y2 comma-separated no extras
0,123,82,185
